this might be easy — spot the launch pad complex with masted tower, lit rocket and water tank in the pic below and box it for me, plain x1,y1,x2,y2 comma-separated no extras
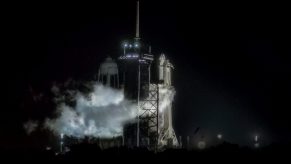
98,2,178,148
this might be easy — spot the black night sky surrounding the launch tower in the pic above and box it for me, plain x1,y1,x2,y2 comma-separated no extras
1,0,291,149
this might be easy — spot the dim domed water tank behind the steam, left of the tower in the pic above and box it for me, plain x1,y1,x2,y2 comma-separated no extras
98,57,119,88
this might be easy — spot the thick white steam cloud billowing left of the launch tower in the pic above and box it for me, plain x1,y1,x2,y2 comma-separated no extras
45,84,137,138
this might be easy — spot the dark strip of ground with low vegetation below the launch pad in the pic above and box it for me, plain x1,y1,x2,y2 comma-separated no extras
1,143,291,163
